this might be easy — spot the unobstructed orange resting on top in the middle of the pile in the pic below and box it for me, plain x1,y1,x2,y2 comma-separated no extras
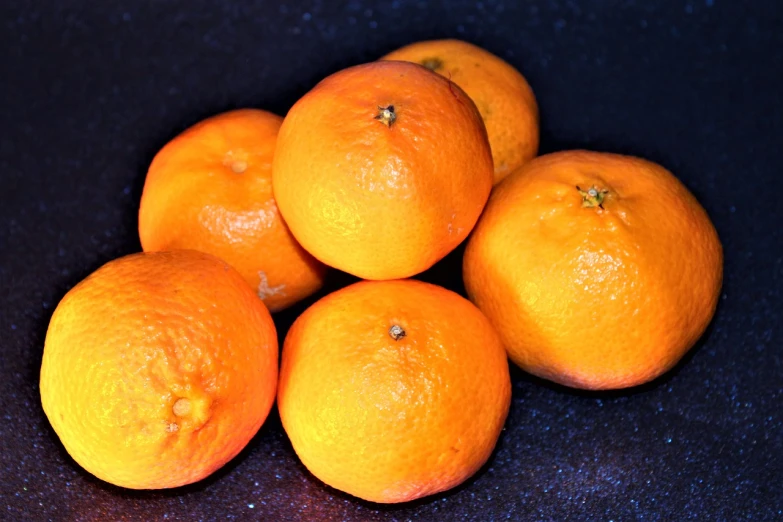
273,62,492,279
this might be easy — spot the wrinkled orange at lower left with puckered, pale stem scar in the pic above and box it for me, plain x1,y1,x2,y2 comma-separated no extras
40,250,278,489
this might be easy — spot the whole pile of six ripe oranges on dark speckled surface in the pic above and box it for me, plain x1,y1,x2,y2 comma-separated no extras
40,40,723,502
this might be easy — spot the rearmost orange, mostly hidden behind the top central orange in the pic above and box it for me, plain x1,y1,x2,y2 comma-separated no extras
382,40,538,183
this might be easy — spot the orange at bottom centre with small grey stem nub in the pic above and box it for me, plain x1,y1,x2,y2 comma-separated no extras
278,280,511,503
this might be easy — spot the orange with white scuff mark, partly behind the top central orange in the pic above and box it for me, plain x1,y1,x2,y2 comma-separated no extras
139,109,325,312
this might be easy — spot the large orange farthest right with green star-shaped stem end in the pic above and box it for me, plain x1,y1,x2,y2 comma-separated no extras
463,151,723,389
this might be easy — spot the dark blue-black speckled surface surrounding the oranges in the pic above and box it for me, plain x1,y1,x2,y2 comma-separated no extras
0,0,783,520
